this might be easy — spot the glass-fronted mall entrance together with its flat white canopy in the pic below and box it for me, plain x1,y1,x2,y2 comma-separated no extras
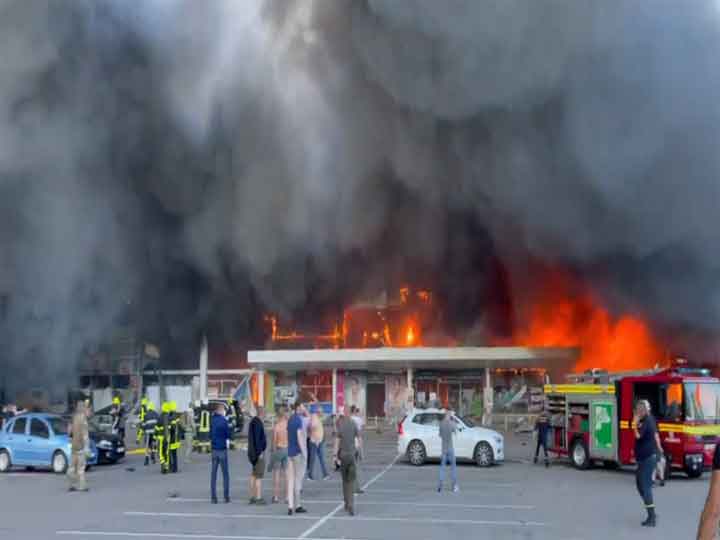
248,347,579,418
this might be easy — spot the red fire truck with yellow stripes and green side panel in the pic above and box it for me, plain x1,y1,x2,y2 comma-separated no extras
544,367,720,478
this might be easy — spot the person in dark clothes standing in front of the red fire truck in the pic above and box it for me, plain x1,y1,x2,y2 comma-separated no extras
633,399,662,527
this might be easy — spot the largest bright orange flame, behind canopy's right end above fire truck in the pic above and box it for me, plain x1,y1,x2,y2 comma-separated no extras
511,271,664,372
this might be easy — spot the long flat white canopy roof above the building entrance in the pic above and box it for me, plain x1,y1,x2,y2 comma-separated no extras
248,347,580,372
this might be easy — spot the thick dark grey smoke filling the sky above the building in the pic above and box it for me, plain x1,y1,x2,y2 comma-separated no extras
0,0,720,388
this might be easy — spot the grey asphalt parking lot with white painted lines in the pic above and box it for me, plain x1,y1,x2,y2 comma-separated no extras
0,434,707,540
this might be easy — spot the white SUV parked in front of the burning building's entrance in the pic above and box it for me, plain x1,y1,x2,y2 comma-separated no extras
398,409,505,467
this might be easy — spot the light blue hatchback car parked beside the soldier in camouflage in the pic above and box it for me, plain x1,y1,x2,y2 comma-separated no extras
0,413,98,474
